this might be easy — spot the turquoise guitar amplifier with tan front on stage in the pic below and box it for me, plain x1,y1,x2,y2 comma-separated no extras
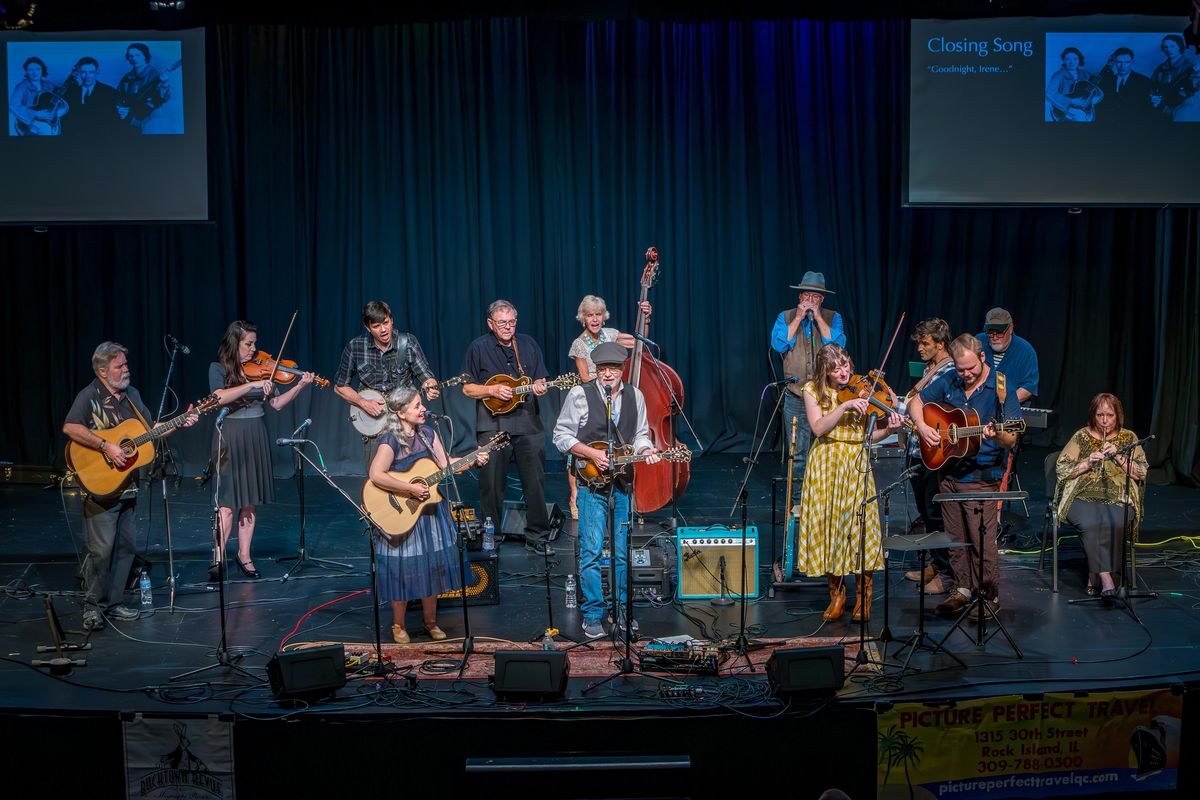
676,525,758,600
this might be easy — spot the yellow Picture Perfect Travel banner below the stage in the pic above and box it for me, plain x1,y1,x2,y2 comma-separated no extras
878,688,1183,800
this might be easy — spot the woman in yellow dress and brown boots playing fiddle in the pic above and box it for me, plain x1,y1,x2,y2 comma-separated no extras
796,344,901,622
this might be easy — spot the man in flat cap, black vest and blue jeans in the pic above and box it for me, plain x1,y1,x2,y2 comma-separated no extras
553,342,659,639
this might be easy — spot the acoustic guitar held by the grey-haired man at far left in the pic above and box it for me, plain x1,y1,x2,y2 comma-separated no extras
66,395,221,500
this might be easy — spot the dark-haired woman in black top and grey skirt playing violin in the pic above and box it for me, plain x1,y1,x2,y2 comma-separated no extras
209,319,313,581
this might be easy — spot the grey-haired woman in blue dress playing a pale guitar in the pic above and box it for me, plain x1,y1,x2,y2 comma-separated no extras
370,386,487,644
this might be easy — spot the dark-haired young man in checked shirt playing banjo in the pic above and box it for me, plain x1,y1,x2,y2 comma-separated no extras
334,300,440,465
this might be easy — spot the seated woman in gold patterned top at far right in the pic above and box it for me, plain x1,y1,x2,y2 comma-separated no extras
1057,392,1146,597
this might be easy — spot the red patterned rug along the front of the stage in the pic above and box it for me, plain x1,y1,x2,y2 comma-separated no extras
284,637,880,680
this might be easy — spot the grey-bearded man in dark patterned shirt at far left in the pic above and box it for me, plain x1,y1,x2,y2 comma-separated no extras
62,342,199,631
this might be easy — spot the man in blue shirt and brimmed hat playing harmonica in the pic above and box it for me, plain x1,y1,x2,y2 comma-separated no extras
770,271,846,481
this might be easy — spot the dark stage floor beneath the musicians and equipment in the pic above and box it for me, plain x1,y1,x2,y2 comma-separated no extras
0,450,1200,715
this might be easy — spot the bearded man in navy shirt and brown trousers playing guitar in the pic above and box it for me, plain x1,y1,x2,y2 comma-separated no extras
908,333,1021,618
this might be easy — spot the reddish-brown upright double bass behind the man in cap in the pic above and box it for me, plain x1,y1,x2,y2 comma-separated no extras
623,246,691,513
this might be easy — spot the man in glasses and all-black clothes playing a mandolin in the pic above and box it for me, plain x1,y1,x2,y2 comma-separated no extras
461,300,554,555
